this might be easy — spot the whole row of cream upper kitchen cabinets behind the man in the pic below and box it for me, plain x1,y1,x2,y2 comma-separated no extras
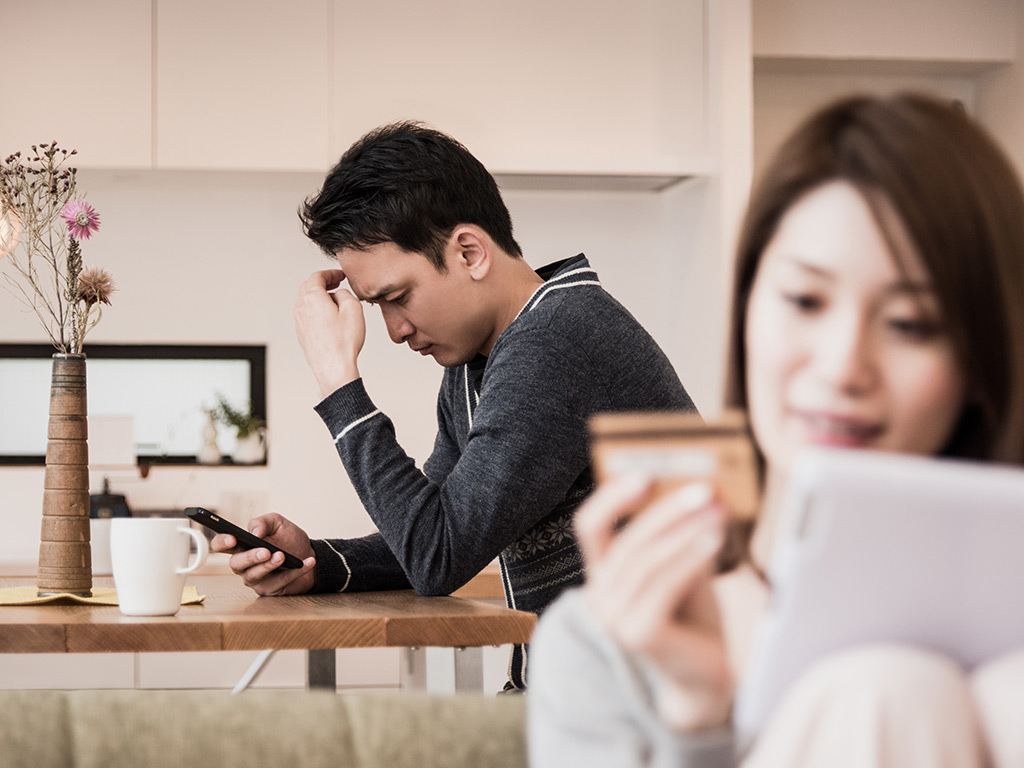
0,0,715,190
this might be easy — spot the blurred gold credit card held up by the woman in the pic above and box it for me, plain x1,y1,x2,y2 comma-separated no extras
590,411,761,519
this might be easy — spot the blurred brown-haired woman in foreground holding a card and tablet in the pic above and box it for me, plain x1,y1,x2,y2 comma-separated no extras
529,95,1024,768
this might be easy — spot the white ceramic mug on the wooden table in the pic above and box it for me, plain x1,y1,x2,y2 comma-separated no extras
111,517,210,616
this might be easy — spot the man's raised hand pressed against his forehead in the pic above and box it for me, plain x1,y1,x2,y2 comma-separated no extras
295,269,367,397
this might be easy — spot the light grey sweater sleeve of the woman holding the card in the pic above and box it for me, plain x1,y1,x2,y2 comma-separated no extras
526,590,737,768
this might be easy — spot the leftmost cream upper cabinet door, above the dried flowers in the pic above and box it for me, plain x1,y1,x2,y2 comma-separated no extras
0,0,153,168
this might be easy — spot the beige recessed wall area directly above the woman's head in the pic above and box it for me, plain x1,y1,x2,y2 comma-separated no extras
752,0,1024,182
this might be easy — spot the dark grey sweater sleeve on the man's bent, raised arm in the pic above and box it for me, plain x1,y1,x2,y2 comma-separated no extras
316,331,600,595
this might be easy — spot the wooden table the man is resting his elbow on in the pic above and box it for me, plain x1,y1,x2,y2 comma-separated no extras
0,574,537,689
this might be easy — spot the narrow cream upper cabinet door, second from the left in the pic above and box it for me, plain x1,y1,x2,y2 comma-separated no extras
156,0,330,171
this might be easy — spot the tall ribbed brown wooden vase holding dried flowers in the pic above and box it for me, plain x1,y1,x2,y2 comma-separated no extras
37,353,92,597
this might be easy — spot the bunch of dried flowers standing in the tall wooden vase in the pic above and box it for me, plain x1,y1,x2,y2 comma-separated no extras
0,141,114,353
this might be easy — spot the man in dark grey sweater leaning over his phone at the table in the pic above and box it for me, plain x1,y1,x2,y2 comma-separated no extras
214,123,693,688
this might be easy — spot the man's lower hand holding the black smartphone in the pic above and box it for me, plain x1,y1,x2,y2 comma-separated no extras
210,514,316,595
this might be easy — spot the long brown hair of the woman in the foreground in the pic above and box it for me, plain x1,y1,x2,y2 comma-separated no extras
719,94,1024,570
